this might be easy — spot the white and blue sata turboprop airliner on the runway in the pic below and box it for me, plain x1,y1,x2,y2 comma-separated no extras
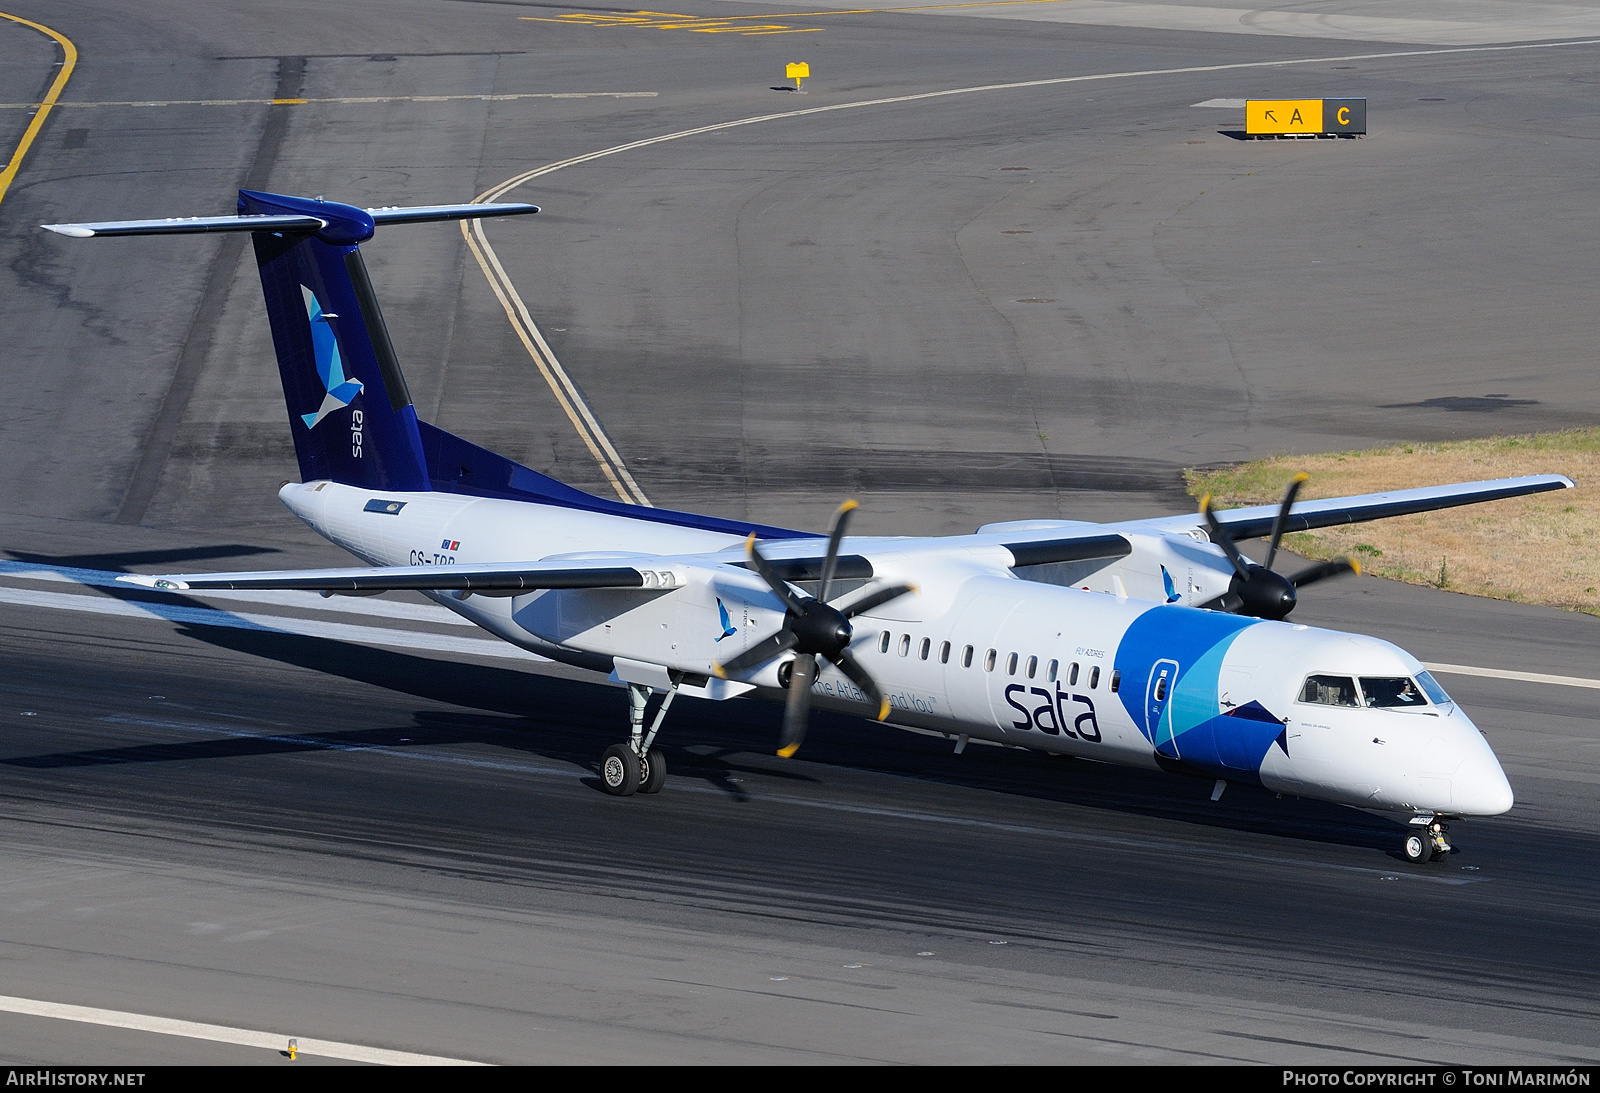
46,190,1573,863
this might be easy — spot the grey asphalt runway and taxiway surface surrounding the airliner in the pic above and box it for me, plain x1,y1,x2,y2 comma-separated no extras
0,0,1600,1064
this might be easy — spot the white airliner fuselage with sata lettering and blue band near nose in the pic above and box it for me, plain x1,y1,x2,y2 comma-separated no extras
280,482,1512,815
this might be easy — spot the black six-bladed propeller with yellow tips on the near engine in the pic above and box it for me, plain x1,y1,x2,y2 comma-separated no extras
712,501,917,759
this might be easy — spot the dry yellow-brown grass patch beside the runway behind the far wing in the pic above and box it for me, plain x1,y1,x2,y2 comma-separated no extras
1184,429,1600,615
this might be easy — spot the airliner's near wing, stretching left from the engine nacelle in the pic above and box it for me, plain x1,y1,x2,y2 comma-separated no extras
117,559,656,595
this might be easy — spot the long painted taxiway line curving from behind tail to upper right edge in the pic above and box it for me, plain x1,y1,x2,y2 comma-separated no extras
461,38,1600,504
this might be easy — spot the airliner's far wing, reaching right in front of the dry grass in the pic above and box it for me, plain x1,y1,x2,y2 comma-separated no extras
1115,474,1576,539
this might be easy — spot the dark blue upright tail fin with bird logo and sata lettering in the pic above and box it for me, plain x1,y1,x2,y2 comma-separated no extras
238,190,429,491
